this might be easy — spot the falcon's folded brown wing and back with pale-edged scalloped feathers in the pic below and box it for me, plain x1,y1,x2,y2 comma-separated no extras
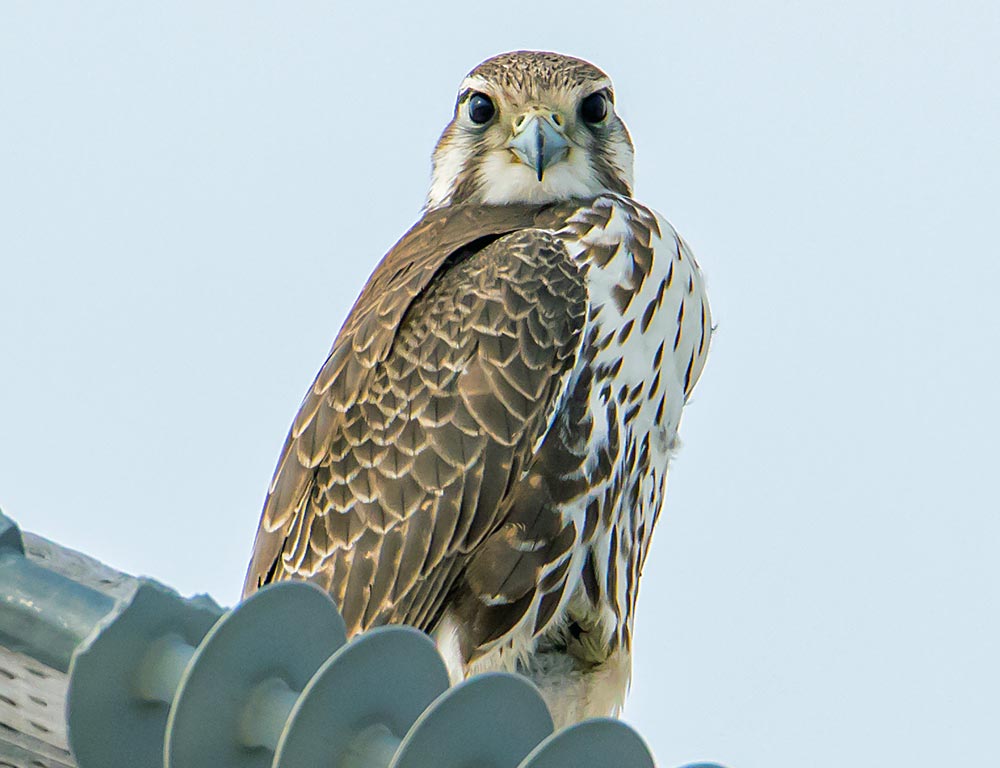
244,202,587,631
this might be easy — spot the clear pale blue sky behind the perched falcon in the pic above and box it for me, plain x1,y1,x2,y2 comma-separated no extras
0,0,1000,768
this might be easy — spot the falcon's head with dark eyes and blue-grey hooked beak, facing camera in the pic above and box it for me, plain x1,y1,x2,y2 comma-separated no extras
427,51,634,208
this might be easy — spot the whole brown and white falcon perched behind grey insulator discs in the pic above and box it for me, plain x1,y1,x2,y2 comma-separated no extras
243,51,713,726
